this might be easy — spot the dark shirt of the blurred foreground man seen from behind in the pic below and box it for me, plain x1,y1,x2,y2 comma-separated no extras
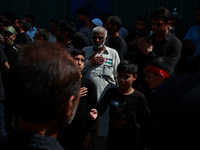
0,127,64,150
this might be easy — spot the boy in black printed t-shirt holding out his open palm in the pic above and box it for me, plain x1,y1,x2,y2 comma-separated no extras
90,60,150,150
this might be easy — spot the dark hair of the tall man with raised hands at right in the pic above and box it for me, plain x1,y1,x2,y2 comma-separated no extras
151,7,172,23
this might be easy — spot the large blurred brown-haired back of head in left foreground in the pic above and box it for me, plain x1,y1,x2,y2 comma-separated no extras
11,41,80,123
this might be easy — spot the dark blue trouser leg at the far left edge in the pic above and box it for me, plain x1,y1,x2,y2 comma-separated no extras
0,101,6,137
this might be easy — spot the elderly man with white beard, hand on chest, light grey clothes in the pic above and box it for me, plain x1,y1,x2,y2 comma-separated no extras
82,26,120,150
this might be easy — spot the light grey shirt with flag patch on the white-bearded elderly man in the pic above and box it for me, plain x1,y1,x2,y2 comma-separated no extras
82,46,120,136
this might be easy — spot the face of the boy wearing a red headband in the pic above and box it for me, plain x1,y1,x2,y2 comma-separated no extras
144,71,164,90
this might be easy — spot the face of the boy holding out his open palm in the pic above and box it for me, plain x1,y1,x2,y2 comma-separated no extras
117,72,137,89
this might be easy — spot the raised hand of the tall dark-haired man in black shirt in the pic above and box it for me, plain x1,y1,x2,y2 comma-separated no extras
137,37,153,55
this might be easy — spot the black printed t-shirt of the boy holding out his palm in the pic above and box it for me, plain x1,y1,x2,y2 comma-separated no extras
97,88,150,150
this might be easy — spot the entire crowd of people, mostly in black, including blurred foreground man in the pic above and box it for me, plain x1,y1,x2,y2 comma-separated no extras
0,6,200,150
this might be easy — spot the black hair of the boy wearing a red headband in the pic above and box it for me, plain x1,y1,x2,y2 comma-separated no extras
144,56,173,76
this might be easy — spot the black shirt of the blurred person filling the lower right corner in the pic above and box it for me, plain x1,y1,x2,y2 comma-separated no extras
148,71,200,150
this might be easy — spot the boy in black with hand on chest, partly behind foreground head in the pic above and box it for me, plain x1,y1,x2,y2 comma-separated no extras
57,49,98,150
